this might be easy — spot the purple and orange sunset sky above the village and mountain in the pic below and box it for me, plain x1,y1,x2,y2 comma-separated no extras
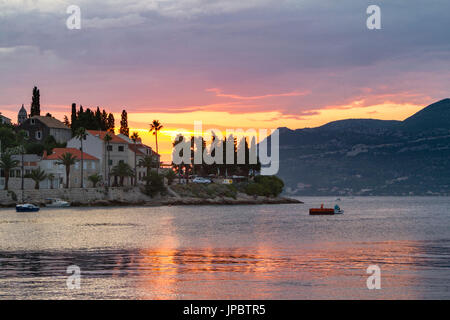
0,0,450,161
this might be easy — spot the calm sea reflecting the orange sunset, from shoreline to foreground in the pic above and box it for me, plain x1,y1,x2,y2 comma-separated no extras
0,197,450,299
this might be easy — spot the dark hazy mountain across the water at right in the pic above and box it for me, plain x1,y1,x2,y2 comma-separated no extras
268,99,450,195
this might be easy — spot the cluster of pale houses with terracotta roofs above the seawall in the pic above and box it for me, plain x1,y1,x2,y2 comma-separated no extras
0,90,160,190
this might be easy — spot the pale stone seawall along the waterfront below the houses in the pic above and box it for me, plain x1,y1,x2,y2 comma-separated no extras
0,187,152,206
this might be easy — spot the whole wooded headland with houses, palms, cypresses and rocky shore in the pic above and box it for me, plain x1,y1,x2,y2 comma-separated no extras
0,87,293,206
